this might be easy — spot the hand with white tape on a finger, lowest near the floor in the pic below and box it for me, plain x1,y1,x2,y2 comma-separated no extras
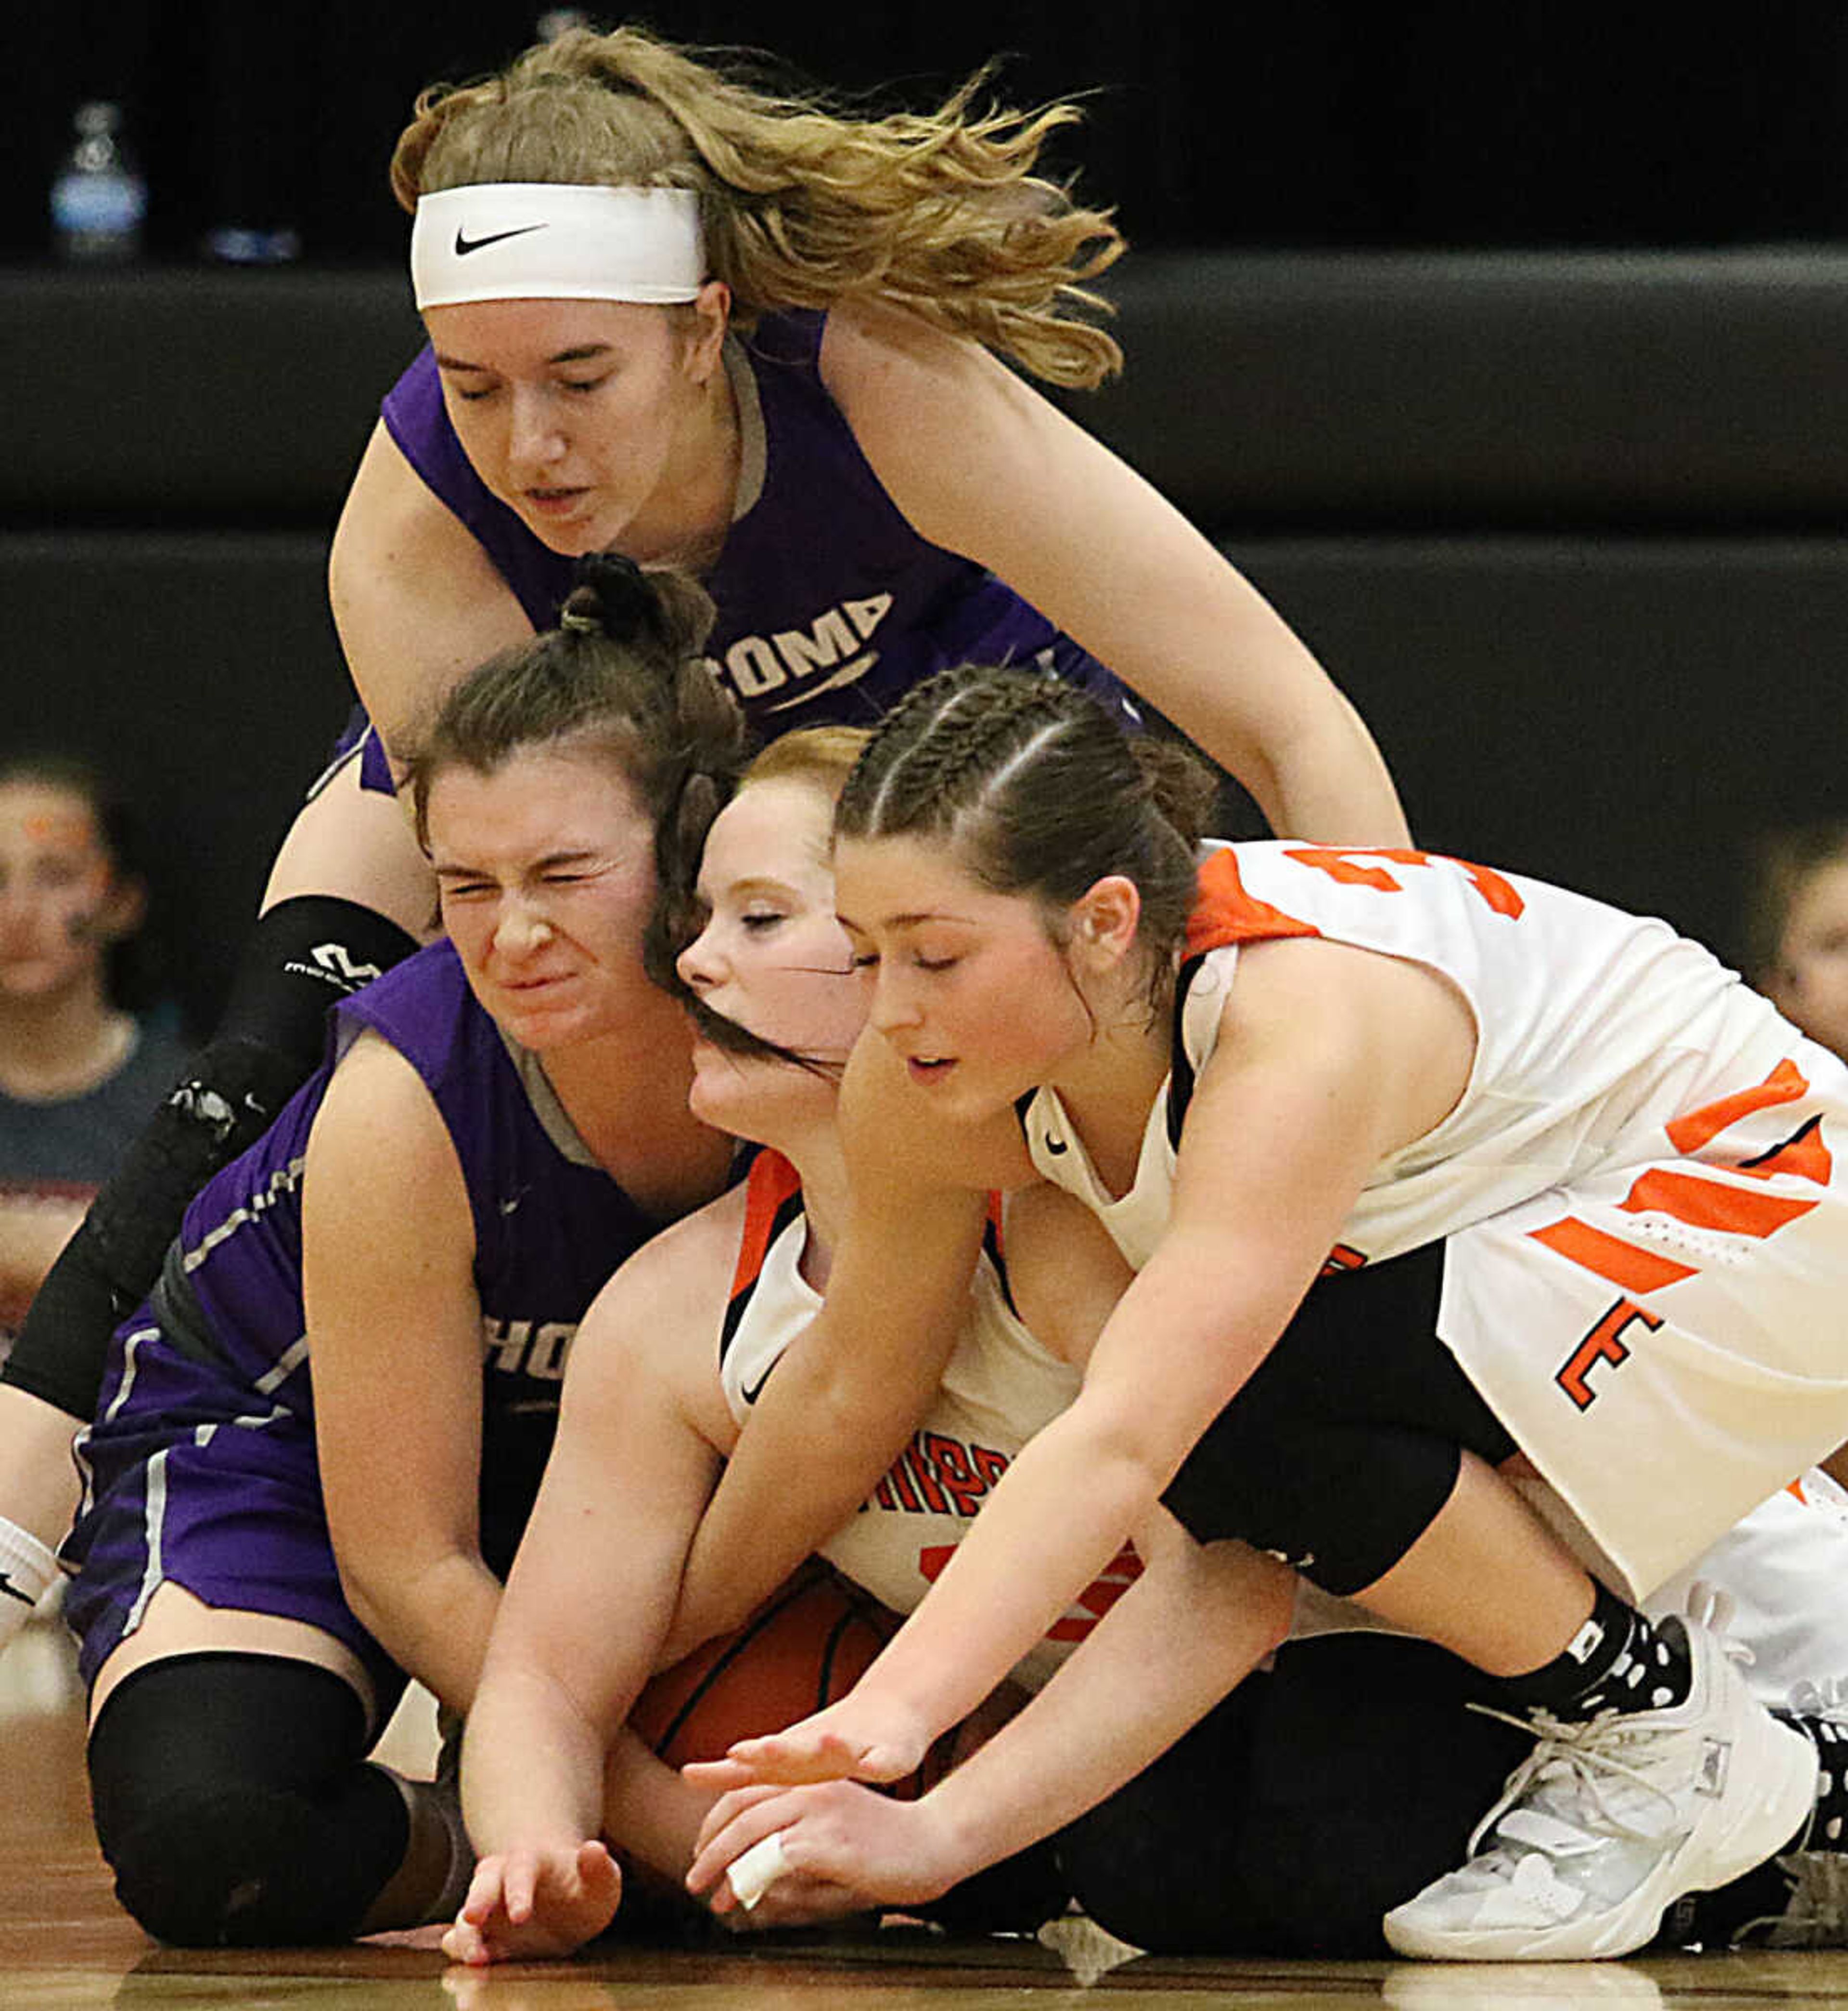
686,1780,957,1914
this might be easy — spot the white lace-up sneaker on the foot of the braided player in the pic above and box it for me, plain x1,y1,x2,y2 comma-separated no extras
1384,1615,1816,1963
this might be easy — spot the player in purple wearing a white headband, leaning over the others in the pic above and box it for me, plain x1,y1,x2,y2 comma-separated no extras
0,30,1406,1665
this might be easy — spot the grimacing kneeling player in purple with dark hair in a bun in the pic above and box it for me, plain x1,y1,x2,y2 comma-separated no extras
66,559,742,1945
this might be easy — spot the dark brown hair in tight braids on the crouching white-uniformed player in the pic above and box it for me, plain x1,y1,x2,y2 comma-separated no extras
834,668,1215,995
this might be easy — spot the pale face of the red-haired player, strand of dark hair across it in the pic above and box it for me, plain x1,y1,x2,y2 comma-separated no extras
680,776,867,1142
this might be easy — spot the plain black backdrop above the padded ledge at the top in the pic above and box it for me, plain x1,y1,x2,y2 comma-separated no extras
18,0,1848,259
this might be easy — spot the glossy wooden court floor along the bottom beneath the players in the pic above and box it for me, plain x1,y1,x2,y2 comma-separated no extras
11,1665,1848,2011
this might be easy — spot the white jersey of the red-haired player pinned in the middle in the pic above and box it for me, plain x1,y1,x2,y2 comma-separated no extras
720,1154,1138,1689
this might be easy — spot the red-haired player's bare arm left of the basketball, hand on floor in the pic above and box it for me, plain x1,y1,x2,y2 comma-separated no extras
449,1197,740,1963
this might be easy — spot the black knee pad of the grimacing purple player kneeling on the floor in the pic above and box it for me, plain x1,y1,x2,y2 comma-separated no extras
89,1653,410,1948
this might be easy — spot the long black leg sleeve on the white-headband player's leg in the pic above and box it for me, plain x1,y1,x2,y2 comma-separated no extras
0,895,416,1420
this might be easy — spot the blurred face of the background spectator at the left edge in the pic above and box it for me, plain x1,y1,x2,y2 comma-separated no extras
0,780,127,999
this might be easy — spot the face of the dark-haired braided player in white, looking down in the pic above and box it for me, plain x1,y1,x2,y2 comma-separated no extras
834,838,1092,1120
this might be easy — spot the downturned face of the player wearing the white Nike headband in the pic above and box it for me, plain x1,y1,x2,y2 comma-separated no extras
424,300,722,557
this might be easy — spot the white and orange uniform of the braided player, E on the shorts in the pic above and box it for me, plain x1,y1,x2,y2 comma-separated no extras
1024,840,1848,1597
